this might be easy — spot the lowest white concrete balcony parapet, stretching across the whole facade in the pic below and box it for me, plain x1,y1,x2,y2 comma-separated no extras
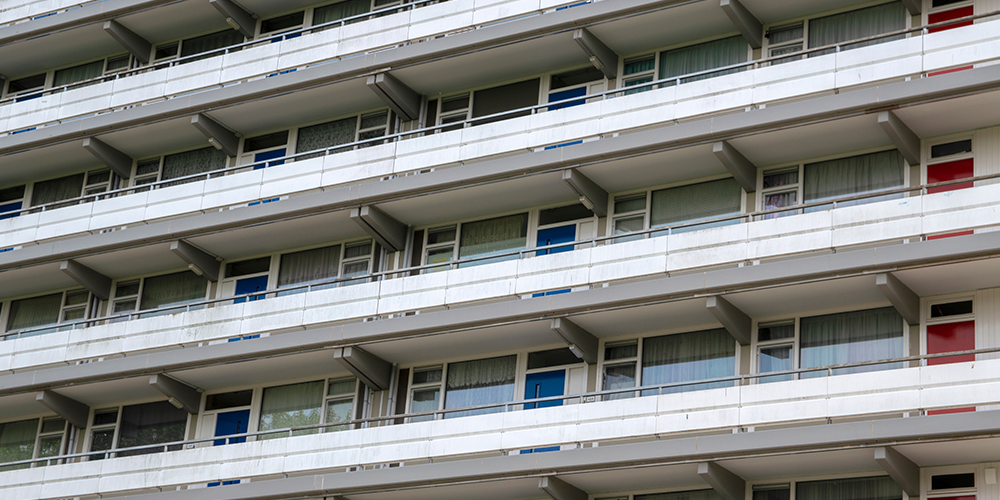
0,360,1000,500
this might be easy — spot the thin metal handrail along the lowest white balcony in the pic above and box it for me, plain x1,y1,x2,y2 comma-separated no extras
0,347,1000,467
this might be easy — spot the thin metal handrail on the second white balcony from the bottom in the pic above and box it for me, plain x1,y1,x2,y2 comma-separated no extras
0,173,1000,341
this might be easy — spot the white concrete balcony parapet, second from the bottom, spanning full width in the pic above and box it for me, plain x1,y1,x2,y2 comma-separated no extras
0,184,1000,371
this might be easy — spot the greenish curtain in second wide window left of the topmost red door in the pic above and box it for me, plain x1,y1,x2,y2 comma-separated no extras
660,36,750,85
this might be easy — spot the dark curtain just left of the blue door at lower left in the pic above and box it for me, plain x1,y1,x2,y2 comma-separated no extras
118,401,187,456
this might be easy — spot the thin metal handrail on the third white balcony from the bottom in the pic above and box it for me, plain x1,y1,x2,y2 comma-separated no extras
0,7,1000,218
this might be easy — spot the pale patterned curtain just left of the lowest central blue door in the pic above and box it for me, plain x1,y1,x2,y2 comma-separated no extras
444,356,517,418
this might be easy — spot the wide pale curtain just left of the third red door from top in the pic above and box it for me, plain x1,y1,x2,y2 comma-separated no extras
799,307,903,377
